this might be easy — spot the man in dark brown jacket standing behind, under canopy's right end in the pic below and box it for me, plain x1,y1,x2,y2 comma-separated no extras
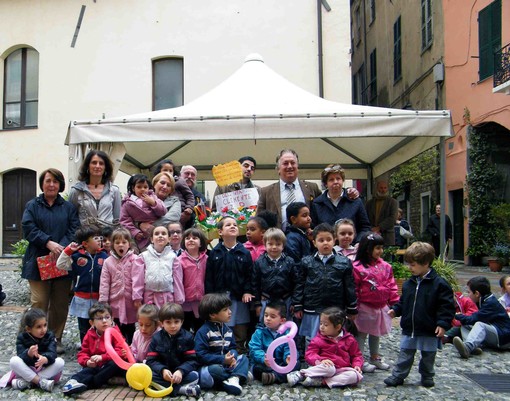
365,181,398,246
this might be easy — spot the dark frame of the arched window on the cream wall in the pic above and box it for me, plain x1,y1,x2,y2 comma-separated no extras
2,47,39,131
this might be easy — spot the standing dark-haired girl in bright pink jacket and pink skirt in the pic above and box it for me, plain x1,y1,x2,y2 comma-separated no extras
353,233,399,373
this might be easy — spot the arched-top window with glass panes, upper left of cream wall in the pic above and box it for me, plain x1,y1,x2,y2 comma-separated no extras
3,48,39,129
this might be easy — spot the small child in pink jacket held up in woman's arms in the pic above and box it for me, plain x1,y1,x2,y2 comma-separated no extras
120,174,167,252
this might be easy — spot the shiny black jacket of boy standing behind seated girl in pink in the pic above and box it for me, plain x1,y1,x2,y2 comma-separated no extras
292,253,358,315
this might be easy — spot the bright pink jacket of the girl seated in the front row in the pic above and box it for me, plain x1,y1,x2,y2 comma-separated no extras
305,330,363,369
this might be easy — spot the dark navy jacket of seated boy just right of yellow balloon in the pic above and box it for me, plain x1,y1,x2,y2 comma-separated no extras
147,329,198,377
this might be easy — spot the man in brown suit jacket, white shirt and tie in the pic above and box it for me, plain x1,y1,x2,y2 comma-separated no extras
257,149,322,230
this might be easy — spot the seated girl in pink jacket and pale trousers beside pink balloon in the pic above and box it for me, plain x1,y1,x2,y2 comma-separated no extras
287,307,363,388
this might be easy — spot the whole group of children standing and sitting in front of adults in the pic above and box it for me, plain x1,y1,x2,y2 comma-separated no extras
3,198,510,396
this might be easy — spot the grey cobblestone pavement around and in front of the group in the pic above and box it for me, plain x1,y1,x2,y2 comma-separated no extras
0,259,510,401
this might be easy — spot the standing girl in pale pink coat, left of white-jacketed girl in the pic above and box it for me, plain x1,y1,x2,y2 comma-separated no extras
99,228,144,344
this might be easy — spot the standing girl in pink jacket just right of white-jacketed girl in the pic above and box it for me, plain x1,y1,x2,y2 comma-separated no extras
178,228,207,333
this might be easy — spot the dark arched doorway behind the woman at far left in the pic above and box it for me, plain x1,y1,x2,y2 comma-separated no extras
2,169,36,255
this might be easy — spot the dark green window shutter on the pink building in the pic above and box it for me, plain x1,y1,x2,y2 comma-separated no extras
478,0,501,81
